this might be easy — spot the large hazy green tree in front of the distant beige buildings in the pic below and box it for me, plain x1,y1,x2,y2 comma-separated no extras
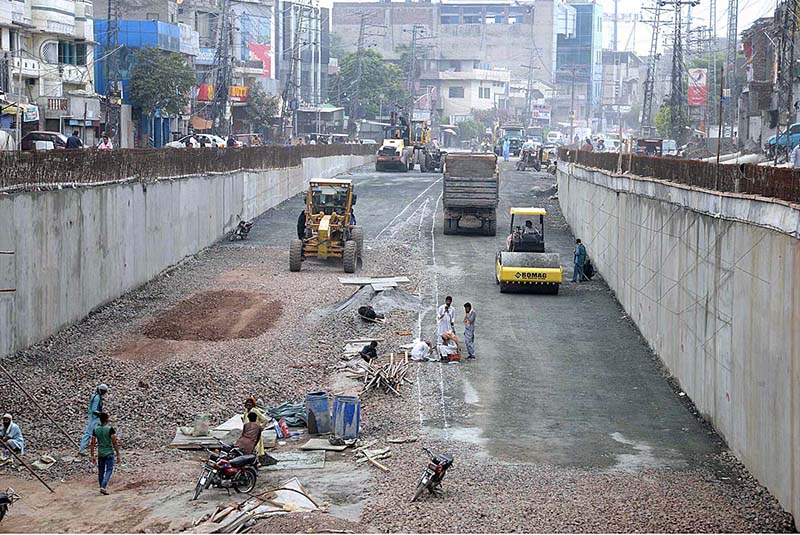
329,50,408,119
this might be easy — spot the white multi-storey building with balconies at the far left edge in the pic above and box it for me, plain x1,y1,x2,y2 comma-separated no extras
0,0,100,143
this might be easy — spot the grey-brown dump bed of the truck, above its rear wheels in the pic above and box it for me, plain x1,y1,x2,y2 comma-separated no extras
442,153,499,208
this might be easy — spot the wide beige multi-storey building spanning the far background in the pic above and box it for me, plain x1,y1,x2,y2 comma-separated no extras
332,0,574,86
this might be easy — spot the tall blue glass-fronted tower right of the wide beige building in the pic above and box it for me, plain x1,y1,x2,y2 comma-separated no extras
553,2,603,130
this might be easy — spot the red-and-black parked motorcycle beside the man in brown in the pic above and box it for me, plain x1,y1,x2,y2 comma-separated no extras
193,441,258,500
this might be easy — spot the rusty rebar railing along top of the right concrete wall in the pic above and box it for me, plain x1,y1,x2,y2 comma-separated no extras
558,147,800,202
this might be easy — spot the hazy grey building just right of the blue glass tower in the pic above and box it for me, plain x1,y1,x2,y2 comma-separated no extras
600,50,644,130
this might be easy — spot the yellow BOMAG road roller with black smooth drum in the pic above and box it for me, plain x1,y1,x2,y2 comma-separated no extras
495,208,564,294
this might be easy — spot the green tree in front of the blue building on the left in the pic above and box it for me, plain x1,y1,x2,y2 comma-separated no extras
128,47,197,115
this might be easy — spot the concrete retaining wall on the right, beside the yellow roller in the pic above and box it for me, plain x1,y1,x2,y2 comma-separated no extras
558,162,800,518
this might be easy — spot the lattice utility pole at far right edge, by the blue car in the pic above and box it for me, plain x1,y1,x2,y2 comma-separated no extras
773,0,797,164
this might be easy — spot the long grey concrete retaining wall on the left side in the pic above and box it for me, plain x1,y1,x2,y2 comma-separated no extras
0,156,374,356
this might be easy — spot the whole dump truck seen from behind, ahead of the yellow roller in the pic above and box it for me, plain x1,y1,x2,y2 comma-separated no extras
442,153,500,236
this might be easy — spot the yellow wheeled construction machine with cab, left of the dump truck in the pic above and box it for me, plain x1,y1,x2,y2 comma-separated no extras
289,179,364,273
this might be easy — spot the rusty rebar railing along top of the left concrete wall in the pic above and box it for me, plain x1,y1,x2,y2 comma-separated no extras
0,144,375,191
